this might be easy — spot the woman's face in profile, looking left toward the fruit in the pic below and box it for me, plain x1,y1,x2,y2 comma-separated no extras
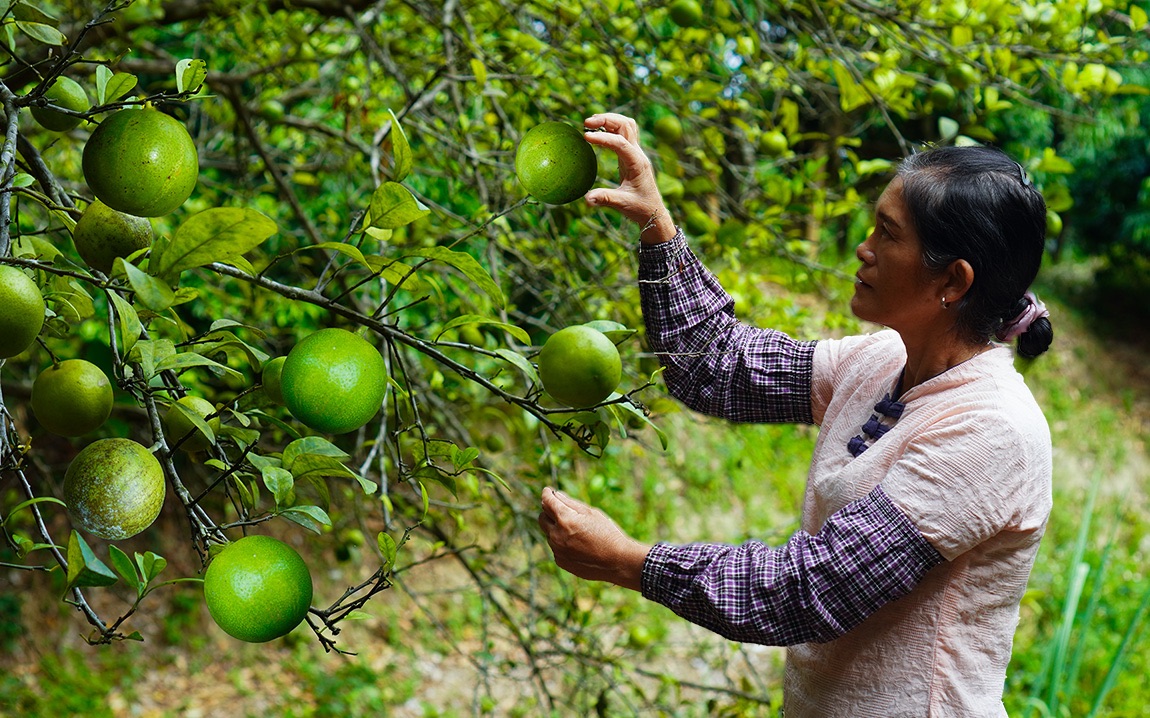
851,177,943,331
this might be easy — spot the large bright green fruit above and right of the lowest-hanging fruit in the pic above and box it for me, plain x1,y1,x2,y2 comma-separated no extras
279,329,388,434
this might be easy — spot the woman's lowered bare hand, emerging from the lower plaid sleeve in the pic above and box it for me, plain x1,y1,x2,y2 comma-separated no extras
539,487,651,590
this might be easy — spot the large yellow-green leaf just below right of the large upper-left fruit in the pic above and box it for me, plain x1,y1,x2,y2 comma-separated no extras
148,207,279,276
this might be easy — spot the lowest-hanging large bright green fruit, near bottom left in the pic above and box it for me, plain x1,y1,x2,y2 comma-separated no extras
204,535,312,643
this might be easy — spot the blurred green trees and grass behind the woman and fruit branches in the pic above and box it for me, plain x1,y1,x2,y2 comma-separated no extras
0,0,1150,716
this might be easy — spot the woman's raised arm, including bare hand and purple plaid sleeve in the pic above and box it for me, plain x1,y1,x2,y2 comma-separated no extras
584,113,814,422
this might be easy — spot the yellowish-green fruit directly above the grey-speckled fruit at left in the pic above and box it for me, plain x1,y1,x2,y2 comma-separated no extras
32,359,113,436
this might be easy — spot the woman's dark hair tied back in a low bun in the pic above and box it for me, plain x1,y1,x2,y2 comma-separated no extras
898,146,1053,358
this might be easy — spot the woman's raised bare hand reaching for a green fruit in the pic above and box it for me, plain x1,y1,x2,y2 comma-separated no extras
583,113,675,244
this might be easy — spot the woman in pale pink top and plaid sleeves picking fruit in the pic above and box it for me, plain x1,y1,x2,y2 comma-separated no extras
539,114,1051,718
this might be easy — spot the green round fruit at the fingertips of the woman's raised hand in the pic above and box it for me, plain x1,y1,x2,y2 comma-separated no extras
515,122,599,205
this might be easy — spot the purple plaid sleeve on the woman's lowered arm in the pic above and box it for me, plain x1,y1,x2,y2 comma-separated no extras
643,487,943,646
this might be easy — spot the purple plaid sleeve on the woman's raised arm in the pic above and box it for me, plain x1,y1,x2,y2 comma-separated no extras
639,230,814,423
